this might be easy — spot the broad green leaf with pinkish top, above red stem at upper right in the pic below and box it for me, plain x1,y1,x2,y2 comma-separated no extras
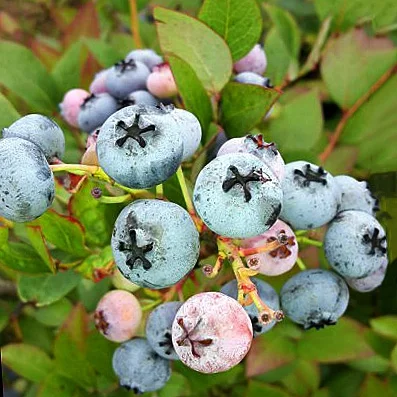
321,29,397,109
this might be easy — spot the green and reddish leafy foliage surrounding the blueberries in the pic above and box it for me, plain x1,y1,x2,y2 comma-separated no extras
0,0,397,397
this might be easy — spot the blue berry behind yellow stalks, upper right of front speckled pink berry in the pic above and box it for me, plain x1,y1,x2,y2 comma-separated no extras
220,277,280,337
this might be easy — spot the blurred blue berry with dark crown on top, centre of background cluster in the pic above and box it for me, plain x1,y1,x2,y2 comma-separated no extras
105,60,150,99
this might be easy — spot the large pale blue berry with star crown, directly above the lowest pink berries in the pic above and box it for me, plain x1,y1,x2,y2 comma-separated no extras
111,200,200,289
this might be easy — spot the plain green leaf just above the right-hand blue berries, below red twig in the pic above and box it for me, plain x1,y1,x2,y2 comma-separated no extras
270,90,323,153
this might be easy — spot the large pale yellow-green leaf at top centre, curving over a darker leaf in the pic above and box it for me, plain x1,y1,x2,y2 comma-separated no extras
154,7,232,93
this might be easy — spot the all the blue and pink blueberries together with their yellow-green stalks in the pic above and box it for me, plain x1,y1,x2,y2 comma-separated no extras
0,45,388,393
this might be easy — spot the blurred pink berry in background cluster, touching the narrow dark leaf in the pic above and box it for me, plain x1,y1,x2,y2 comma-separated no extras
146,63,178,98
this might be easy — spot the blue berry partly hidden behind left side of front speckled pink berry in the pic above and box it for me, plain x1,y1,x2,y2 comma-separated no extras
146,302,182,360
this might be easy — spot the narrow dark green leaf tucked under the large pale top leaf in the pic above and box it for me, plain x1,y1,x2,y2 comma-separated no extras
168,55,212,132
